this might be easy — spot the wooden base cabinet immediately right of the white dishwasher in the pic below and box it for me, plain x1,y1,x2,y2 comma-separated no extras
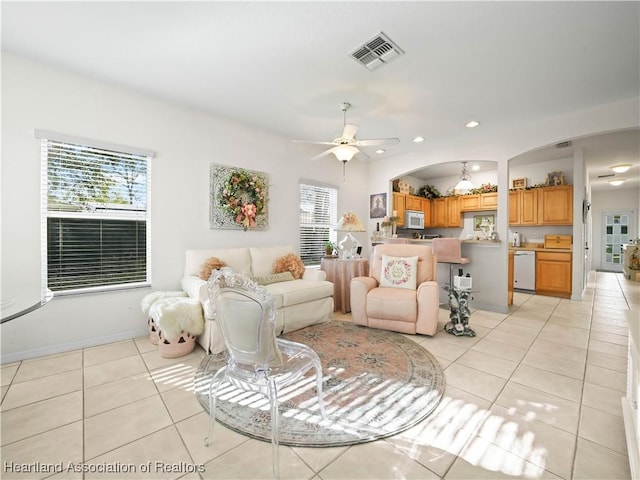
536,252,571,298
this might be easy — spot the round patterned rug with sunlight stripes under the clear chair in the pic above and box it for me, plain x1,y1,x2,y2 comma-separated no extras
195,321,444,447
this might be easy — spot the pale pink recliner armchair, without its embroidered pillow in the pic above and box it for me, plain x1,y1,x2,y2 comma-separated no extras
351,244,439,335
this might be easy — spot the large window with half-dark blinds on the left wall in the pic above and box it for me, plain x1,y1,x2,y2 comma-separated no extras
36,132,152,293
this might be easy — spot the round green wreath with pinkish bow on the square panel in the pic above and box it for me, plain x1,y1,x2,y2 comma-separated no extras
220,168,267,230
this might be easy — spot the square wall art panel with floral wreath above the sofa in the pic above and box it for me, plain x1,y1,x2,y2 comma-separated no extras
209,163,269,231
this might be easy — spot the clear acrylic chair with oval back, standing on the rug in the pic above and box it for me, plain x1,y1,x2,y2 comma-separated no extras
205,268,326,478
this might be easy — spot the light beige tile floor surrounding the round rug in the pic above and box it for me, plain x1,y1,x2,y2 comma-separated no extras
0,272,640,480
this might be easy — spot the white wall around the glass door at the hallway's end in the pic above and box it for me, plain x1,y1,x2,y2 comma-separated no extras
590,185,640,270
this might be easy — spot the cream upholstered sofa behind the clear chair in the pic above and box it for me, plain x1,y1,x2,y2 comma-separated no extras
181,245,333,353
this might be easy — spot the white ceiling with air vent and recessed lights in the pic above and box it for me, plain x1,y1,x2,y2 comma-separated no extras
1,1,640,189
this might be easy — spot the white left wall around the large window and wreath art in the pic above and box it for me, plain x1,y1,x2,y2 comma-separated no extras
0,52,369,363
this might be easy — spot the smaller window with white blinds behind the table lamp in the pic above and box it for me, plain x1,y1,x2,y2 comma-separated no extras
300,182,338,265
